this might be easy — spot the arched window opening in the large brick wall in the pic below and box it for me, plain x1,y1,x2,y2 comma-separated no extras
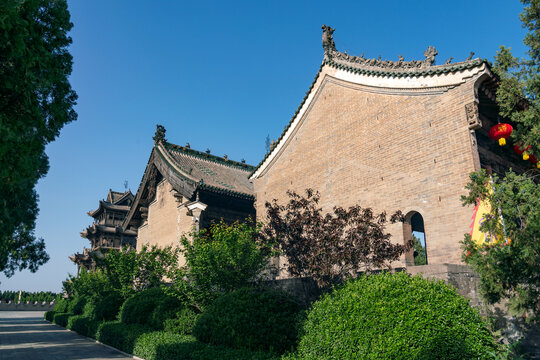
403,211,428,266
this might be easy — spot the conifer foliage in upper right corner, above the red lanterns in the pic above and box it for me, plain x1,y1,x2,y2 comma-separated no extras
493,0,540,158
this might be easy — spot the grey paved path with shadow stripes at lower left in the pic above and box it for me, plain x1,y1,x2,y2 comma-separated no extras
0,311,133,360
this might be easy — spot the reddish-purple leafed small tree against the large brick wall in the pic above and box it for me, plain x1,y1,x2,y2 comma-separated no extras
262,189,412,287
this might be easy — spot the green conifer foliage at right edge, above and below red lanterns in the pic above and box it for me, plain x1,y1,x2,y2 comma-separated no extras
463,0,540,319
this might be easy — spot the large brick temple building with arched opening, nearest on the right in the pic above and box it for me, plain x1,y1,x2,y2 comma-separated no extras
250,26,533,276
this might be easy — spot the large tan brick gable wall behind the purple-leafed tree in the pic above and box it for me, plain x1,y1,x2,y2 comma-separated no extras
253,66,490,264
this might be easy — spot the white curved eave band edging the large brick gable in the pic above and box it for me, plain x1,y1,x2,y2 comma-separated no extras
249,59,491,180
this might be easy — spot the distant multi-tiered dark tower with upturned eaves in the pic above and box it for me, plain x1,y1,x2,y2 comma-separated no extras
69,190,137,271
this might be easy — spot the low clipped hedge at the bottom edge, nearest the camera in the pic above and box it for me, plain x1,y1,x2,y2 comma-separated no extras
133,331,279,360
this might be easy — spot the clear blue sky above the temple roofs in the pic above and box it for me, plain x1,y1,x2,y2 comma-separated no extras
0,0,526,291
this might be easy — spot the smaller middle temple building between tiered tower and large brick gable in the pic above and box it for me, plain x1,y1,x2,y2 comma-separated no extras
122,125,255,258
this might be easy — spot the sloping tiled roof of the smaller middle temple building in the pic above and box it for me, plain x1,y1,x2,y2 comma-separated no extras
161,142,254,197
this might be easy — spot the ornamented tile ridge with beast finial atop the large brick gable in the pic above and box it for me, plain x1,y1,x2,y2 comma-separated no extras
322,25,487,77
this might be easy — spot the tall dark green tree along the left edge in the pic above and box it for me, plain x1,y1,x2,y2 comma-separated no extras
0,0,77,276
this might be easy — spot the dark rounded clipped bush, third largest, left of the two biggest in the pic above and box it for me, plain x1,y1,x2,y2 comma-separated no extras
118,287,167,325
